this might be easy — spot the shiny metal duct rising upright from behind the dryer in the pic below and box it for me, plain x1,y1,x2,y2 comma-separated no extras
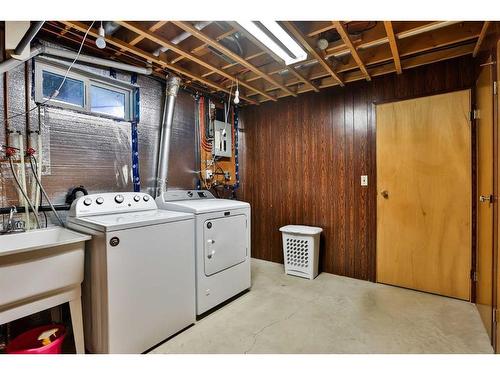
155,75,181,197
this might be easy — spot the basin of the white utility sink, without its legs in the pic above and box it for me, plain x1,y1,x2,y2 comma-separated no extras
0,227,91,312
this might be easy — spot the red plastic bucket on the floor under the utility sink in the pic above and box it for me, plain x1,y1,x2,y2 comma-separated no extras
5,324,66,354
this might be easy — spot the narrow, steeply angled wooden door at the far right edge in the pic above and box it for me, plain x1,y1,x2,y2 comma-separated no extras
476,65,494,339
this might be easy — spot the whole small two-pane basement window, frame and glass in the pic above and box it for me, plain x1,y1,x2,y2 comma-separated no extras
35,58,137,121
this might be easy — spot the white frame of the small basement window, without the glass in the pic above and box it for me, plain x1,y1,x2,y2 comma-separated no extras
34,57,138,122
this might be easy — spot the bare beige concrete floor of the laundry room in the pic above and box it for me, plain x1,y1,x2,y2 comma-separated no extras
152,259,492,353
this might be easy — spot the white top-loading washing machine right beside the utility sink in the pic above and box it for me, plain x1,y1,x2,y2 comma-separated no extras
67,193,196,353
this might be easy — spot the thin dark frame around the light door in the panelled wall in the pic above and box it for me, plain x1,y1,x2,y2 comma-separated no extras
371,88,474,303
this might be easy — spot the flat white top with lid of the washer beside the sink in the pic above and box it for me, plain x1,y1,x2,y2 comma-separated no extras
71,210,194,232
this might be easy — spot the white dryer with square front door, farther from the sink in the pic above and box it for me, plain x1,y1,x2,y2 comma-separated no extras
156,190,251,315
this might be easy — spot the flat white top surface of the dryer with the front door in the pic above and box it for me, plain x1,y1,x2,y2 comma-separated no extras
156,197,250,214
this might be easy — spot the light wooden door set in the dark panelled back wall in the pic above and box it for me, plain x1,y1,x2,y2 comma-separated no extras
376,90,471,300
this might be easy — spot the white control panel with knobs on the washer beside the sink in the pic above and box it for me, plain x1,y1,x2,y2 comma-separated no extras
69,192,158,217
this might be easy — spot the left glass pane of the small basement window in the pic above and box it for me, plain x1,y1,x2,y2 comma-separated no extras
43,70,85,107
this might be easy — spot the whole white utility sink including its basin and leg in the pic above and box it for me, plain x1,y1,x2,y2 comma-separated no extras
0,227,91,354
